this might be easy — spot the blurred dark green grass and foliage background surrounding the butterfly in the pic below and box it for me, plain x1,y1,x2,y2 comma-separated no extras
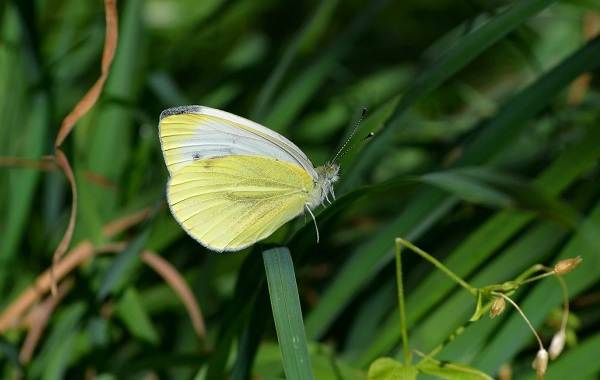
0,0,600,379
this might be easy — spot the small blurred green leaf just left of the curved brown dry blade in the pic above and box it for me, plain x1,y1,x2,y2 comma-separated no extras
117,287,159,344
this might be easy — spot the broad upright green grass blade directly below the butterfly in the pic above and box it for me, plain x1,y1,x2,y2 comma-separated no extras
263,248,313,380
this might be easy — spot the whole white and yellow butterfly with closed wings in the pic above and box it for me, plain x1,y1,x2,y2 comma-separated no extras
159,106,339,252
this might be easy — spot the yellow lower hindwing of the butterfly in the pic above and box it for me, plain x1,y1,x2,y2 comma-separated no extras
167,155,314,252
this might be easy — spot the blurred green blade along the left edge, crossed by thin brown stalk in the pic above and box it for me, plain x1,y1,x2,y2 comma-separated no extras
0,3,51,276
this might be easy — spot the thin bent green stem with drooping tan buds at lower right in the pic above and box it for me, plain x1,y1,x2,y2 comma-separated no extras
396,238,582,379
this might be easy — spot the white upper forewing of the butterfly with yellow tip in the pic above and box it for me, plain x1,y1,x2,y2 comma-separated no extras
159,106,317,179
